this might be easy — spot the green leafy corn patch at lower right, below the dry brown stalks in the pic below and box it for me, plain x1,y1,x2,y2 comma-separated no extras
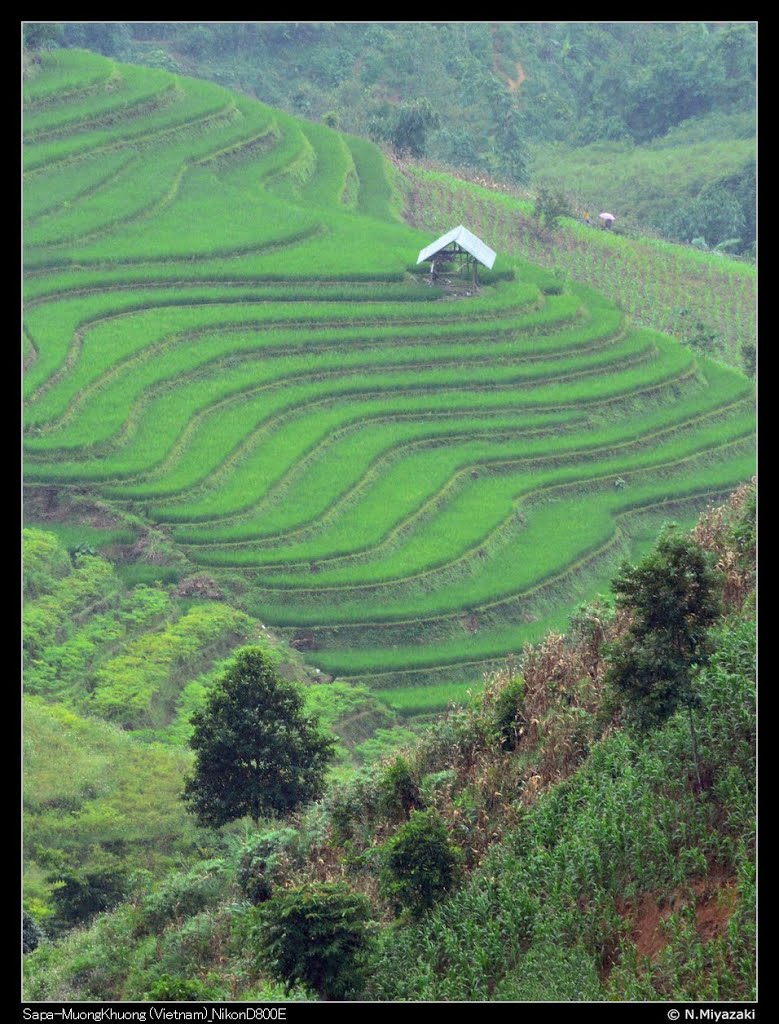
366,598,754,1000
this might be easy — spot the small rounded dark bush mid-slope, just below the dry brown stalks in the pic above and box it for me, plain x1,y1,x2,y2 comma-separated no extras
380,811,463,915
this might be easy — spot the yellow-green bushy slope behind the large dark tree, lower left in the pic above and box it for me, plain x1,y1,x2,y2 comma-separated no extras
24,525,403,931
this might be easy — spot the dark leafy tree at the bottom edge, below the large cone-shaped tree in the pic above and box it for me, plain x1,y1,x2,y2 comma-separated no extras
257,883,371,999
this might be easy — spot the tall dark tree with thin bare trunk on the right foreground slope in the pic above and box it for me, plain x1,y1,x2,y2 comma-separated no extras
607,528,720,781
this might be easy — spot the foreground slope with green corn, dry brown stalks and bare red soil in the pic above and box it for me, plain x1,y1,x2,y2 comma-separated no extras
26,487,755,1001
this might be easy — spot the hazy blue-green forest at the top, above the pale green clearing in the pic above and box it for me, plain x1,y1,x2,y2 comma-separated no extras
66,22,755,202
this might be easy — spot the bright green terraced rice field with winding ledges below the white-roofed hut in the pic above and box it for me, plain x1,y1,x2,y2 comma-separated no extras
25,51,754,711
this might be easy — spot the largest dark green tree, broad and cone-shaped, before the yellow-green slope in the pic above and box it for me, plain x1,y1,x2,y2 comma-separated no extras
184,647,335,826
